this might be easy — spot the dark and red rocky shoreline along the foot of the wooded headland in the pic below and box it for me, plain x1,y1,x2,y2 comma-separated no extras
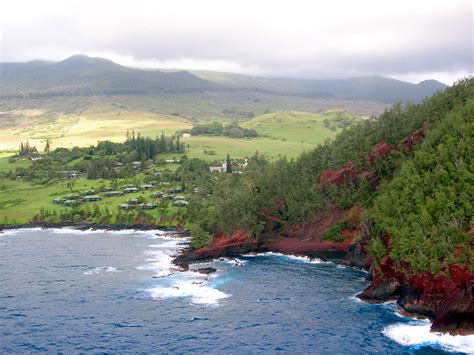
174,231,474,335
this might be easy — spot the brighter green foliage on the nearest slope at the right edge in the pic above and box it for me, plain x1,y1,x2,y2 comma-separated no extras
369,93,474,274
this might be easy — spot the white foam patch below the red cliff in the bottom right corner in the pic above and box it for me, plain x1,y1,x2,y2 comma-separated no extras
382,320,474,354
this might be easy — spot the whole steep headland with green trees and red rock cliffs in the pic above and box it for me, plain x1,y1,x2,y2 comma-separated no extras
184,79,474,333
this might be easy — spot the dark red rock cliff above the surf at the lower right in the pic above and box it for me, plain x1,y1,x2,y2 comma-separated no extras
359,235,474,333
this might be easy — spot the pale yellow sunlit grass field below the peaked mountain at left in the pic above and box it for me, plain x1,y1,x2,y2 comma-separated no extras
0,104,192,150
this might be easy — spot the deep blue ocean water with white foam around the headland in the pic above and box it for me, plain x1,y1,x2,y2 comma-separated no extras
0,229,474,354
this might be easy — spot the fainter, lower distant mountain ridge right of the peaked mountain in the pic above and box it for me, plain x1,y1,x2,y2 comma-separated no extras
191,70,447,103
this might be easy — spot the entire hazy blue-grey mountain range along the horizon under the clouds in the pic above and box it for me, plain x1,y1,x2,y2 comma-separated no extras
0,55,446,103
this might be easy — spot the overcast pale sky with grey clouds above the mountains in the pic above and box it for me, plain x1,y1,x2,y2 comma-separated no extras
0,0,474,84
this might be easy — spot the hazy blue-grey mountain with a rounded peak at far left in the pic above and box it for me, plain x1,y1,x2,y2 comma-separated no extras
0,55,223,97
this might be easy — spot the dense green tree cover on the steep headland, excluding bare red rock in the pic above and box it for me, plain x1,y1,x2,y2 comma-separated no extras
187,78,474,273
